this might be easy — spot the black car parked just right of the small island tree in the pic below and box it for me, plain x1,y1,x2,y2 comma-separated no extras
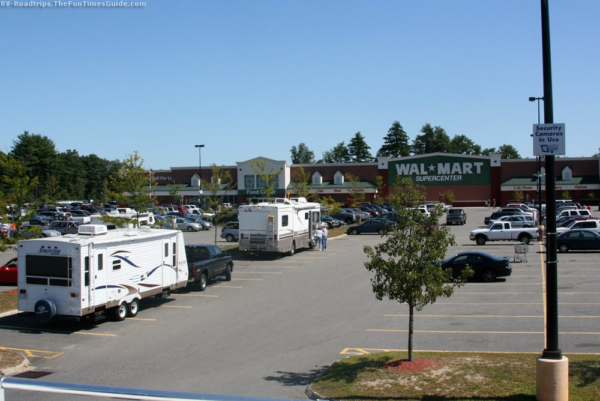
441,252,512,282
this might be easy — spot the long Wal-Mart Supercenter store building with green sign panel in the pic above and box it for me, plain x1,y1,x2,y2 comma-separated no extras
154,153,600,206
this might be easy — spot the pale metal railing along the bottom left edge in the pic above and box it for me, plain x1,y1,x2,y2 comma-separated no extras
0,377,300,401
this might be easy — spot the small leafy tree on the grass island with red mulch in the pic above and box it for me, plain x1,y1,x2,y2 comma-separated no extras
364,178,473,362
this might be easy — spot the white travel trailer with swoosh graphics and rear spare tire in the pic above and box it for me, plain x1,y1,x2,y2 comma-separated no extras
17,224,188,322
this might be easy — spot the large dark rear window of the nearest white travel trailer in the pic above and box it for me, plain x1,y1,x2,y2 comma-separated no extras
25,255,73,287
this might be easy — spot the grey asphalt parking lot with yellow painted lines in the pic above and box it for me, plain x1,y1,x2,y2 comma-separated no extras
0,208,600,400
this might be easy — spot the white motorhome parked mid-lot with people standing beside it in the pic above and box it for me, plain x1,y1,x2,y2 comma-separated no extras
239,198,321,255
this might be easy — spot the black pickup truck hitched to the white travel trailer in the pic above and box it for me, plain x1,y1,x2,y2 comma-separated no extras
185,244,233,291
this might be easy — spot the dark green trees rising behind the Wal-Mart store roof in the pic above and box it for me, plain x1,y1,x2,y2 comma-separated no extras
290,121,521,164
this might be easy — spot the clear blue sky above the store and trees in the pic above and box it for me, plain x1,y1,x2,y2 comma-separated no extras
0,0,600,170
